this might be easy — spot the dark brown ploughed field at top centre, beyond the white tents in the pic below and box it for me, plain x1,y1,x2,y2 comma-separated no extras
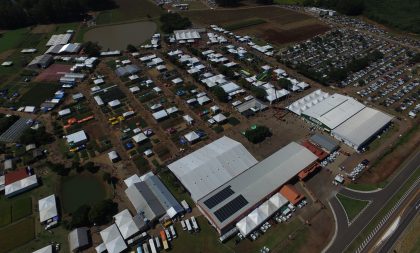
185,7,329,45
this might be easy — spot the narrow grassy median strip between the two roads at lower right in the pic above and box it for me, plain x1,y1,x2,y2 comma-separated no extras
345,168,420,253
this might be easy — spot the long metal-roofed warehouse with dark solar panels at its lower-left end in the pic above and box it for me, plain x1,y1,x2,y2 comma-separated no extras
197,142,317,234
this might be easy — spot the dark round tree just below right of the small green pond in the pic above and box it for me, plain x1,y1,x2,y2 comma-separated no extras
89,199,118,225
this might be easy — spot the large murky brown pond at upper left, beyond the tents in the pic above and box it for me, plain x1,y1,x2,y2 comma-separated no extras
84,21,157,50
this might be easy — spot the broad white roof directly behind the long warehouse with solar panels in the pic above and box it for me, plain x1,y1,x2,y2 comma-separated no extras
168,136,257,201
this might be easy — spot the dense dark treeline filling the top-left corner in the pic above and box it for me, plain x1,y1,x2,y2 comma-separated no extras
0,0,116,29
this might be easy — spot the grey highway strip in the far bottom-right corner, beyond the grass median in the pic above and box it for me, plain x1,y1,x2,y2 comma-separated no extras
377,195,420,253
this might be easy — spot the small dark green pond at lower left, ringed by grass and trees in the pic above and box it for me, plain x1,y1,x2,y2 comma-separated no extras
61,175,107,213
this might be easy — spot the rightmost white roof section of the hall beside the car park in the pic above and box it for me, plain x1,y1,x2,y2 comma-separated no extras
331,107,392,148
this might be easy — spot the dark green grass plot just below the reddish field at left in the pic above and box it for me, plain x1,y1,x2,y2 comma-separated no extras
18,83,60,106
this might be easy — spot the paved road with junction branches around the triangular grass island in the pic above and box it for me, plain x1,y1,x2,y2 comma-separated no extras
324,151,420,253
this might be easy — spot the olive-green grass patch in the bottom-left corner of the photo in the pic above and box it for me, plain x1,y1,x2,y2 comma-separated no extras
0,217,35,253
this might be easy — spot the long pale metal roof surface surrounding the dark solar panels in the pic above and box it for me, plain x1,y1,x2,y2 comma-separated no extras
198,142,318,229
